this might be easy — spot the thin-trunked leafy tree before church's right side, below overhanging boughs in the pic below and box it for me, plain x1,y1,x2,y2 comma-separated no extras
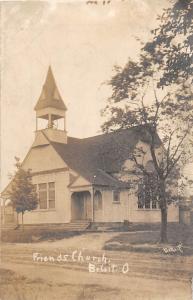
102,73,193,243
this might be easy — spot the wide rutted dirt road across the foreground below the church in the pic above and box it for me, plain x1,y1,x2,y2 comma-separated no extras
0,235,193,300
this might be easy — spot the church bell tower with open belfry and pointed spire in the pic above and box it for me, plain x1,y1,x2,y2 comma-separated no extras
34,66,67,144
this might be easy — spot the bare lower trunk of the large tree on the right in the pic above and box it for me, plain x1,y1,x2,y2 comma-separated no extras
160,179,168,244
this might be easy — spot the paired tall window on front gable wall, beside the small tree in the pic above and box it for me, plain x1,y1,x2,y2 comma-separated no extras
34,182,55,209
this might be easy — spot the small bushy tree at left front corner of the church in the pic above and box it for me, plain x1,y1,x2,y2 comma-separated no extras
9,157,38,228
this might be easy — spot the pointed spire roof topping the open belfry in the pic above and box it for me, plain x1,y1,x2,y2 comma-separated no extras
34,66,67,111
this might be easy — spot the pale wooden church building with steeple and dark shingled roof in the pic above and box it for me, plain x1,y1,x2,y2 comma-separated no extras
2,67,179,229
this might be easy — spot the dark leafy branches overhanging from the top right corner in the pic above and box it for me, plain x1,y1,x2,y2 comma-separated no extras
86,0,193,100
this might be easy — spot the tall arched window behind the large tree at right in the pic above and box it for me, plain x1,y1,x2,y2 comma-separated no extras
138,176,158,209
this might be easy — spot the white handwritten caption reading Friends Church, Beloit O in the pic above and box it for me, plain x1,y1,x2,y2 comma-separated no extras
32,250,129,274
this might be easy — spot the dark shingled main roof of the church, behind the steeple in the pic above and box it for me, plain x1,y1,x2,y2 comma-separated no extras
48,126,159,187
